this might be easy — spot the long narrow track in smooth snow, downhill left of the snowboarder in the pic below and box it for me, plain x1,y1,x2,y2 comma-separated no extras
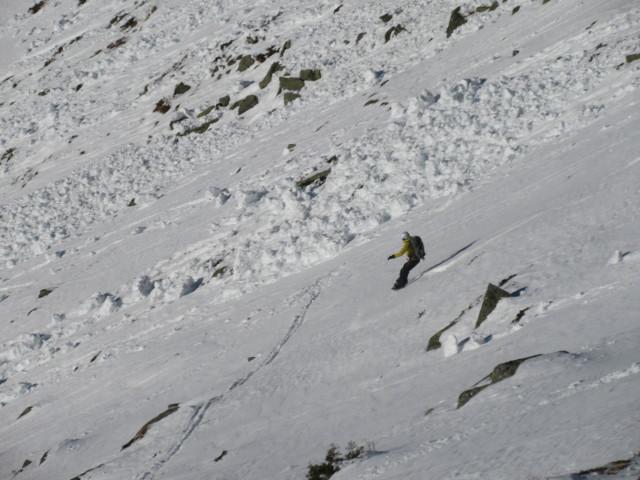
137,273,336,480
